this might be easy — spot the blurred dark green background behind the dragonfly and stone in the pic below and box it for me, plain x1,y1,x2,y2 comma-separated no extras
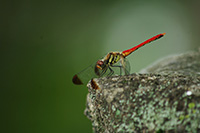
0,0,200,133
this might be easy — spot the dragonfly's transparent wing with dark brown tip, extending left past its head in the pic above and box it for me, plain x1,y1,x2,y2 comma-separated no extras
72,64,98,85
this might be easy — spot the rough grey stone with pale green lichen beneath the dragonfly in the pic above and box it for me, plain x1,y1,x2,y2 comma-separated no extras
85,51,200,133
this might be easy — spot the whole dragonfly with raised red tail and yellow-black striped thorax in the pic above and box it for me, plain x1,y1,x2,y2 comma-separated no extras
72,33,165,85
